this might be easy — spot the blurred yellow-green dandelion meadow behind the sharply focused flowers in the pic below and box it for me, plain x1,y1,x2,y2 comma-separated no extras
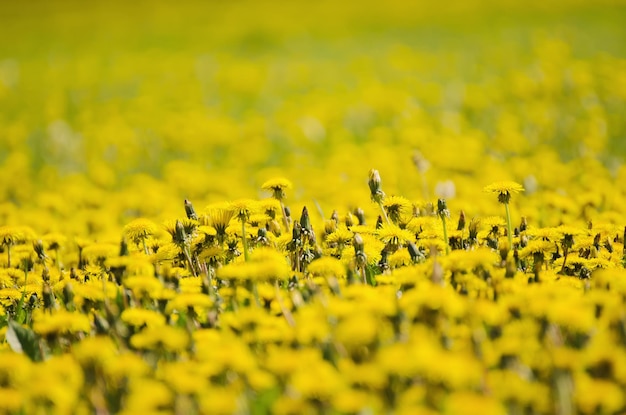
0,0,626,231
